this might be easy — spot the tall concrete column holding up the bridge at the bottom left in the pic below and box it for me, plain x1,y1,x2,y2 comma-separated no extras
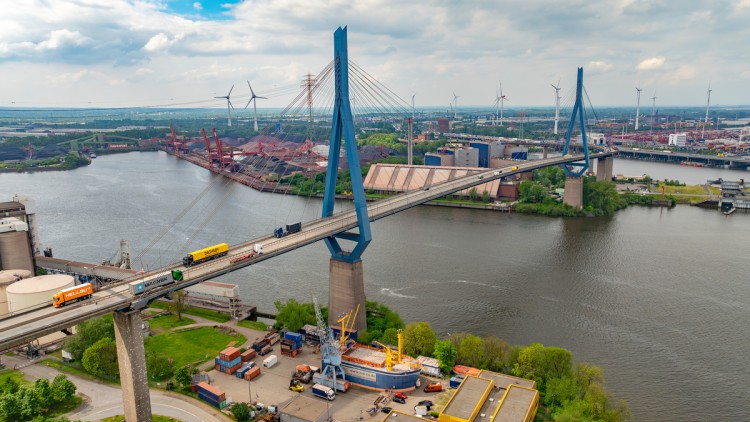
114,312,151,422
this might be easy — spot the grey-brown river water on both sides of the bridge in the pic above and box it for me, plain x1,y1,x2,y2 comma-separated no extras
0,152,750,421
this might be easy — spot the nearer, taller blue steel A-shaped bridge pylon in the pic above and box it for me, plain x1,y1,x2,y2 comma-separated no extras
323,27,372,262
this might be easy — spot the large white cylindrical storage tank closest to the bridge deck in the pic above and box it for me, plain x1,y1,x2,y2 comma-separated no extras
6,274,75,312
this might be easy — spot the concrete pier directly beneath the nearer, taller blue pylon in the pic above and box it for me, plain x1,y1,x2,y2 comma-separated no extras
328,258,367,331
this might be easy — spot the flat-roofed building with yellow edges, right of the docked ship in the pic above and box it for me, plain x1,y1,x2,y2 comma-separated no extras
439,371,539,422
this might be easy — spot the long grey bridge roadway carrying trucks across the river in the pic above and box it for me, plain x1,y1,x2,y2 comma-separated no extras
0,151,612,350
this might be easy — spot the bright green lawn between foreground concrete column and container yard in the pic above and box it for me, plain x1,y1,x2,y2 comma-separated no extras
146,327,246,368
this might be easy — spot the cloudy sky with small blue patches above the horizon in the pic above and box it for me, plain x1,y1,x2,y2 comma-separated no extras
0,0,750,110
